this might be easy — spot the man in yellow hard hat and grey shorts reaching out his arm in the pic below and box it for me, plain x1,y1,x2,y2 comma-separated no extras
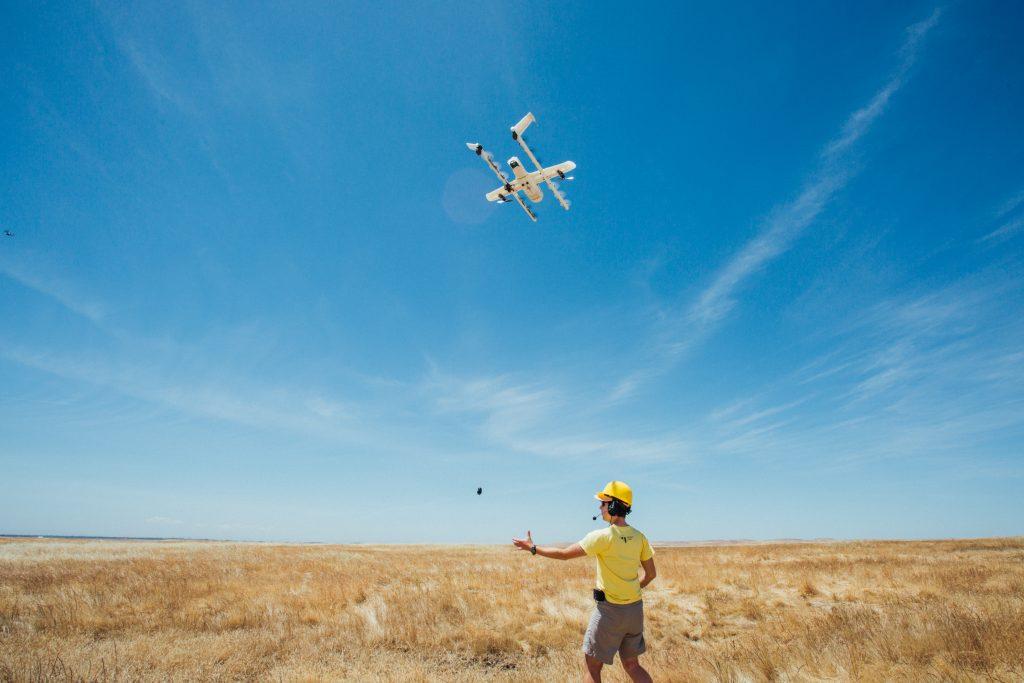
512,481,657,683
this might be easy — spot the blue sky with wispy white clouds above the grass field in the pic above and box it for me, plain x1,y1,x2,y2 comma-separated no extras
0,2,1024,543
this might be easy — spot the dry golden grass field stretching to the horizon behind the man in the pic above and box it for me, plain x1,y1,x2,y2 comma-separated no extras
0,539,1024,681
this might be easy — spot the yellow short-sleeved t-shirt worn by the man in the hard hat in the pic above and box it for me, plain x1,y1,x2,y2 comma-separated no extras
580,524,654,605
